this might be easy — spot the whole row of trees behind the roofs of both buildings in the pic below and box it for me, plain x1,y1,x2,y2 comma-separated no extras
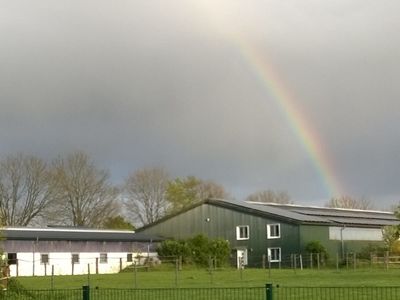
0,152,371,229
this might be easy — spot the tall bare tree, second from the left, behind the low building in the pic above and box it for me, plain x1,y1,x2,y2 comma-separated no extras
53,152,119,227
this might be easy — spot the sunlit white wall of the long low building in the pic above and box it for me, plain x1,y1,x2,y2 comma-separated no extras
10,252,157,276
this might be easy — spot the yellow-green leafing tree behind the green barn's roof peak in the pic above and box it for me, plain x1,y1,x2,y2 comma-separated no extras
166,176,229,212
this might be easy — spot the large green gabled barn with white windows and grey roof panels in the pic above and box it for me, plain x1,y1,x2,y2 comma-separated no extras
137,199,399,266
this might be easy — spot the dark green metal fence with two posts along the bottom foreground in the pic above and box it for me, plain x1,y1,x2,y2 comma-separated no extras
0,284,400,300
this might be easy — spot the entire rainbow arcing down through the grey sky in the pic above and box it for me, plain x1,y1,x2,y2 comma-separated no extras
194,0,345,197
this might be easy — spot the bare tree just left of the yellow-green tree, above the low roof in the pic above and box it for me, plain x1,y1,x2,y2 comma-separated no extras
124,168,169,225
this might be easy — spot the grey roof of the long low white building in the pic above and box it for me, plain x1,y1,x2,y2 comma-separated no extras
2,227,162,242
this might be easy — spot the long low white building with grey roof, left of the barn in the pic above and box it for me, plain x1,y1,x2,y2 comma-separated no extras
1,227,160,276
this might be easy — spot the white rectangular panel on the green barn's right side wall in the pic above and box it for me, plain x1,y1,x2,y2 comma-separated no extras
329,227,383,241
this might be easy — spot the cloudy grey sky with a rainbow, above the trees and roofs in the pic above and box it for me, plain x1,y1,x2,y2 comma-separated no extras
0,0,400,207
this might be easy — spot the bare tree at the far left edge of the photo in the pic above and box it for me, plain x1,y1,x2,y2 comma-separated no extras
0,154,54,226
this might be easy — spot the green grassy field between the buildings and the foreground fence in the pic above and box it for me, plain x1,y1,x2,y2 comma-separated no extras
18,268,400,289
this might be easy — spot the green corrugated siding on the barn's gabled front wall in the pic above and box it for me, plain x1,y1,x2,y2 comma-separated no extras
139,204,299,266
